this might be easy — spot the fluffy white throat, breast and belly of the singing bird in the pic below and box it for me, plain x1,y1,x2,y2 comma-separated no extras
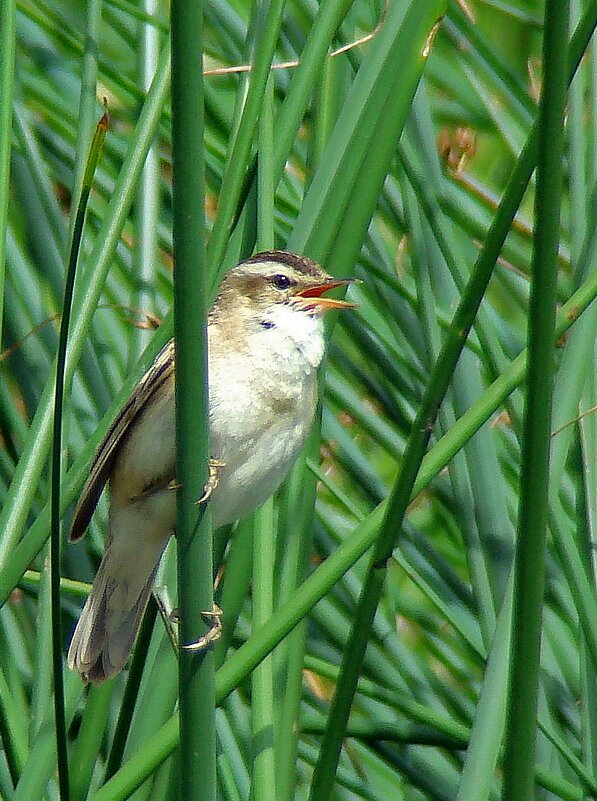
209,304,324,526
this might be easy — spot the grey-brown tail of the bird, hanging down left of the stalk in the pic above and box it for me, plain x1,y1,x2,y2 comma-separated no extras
68,543,165,683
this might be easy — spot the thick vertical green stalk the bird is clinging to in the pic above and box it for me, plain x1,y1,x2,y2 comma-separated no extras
171,0,216,801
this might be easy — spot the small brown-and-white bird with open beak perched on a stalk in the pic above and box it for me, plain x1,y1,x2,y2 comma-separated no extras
68,250,355,684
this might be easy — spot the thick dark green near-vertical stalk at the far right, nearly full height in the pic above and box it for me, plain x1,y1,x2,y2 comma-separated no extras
504,0,569,801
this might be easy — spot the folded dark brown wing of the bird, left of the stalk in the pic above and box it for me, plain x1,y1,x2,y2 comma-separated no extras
69,339,174,542
